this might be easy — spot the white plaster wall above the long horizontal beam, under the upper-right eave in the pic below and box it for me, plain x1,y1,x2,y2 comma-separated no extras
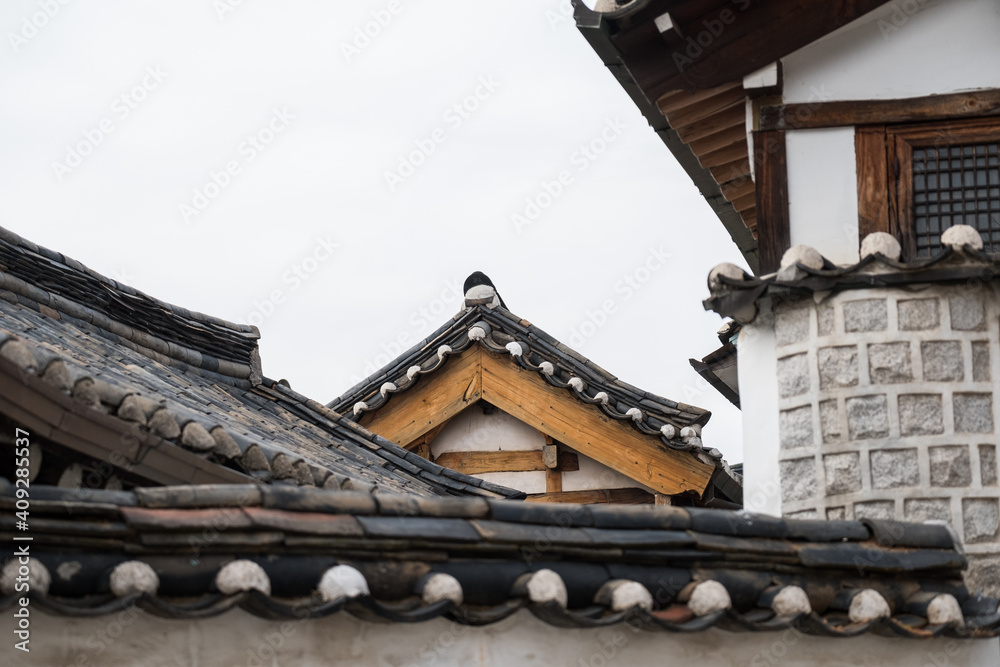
781,0,1000,103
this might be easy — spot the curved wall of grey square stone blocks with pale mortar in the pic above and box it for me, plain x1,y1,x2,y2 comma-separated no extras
774,285,1000,594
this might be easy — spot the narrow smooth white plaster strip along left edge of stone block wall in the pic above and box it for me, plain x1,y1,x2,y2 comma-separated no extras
737,300,781,516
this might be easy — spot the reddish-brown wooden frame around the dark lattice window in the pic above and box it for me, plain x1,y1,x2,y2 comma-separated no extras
854,117,1000,261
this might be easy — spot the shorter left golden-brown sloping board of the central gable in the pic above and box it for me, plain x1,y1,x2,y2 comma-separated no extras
359,345,482,447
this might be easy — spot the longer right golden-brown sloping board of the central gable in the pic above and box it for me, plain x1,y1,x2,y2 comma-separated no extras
482,353,715,495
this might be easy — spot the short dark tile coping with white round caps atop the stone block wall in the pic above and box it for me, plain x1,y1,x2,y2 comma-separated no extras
704,230,1000,324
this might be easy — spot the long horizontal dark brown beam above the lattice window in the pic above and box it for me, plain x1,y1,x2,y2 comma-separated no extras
760,89,1000,130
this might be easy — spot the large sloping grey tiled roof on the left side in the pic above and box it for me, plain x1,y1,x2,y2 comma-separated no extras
0,229,522,497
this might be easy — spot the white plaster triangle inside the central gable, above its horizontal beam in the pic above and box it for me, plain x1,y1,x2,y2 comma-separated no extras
431,406,545,456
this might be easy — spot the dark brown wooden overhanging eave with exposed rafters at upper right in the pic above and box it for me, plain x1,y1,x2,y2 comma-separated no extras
574,0,886,271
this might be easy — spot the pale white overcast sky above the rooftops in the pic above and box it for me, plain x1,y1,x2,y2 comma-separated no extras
0,0,745,463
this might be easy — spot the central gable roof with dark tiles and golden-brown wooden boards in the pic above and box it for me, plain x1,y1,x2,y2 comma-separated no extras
328,276,739,500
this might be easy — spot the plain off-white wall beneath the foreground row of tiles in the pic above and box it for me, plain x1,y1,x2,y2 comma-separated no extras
9,610,1000,667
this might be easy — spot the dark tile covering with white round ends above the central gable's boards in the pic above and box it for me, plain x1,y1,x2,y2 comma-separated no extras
327,284,723,466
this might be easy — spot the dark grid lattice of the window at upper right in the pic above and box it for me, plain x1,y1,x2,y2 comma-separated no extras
913,142,1000,257
